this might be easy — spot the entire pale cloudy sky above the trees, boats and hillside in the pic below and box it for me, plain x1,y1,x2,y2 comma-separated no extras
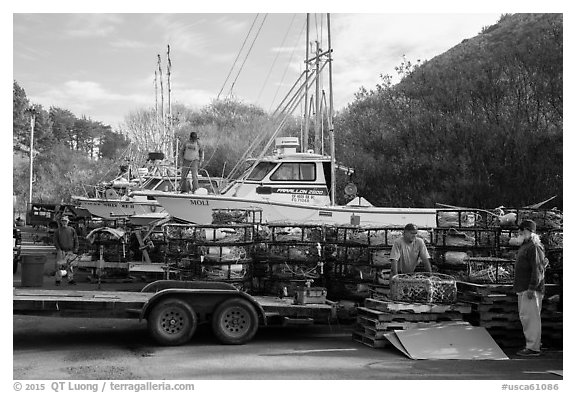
13,11,501,127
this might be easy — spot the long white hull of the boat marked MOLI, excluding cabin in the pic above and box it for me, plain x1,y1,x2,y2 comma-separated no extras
154,193,436,228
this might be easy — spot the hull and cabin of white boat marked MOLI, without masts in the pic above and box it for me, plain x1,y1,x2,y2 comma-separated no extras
138,137,436,227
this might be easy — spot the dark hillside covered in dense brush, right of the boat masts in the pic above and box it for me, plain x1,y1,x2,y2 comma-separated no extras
338,14,563,208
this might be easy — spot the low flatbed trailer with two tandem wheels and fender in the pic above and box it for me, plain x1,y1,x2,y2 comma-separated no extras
13,280,335,345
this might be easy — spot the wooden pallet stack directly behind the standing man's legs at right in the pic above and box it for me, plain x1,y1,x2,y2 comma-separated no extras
458,283,562,347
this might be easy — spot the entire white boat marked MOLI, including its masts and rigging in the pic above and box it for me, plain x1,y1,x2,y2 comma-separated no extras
135,14,436,227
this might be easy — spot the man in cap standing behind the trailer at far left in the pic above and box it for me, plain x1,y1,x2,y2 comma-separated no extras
54,216,78,285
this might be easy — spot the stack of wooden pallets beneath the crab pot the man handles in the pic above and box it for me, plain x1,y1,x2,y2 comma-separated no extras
353,298,471,348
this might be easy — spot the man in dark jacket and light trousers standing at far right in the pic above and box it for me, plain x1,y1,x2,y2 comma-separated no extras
510,220,547,356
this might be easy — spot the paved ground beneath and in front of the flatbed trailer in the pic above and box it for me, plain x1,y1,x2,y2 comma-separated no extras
13,269,563,380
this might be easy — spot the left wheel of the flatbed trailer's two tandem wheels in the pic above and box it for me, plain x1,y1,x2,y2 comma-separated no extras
148,299,198,345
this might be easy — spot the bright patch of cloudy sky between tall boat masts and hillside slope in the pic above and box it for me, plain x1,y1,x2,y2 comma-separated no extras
332,14,498,107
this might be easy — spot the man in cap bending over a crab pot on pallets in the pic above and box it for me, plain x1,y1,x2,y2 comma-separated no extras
390,224,432,278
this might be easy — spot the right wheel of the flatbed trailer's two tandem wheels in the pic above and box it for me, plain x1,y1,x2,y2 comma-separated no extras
212,299,258,344
